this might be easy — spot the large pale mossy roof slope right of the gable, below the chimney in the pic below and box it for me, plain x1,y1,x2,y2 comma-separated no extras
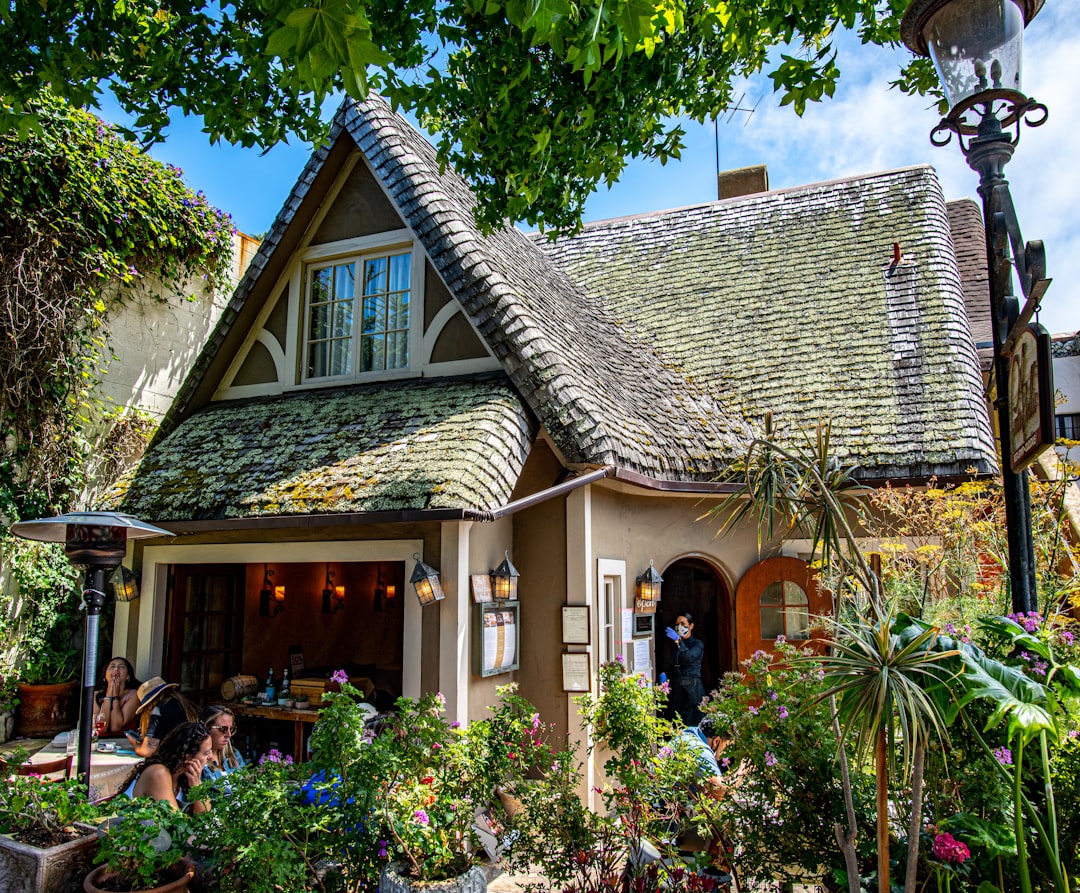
536,166,995,477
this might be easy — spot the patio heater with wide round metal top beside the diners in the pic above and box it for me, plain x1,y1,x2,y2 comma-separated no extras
11,512,173,787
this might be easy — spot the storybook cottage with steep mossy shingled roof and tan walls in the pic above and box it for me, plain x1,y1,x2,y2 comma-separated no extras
109,98,996,794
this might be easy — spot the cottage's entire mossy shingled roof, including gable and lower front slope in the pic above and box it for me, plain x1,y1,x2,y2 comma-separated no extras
126,97,994,520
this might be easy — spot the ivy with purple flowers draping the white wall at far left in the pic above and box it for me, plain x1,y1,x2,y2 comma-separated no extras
0,94,232,702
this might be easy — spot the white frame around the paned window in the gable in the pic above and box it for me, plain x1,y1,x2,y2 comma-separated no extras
294,230,424,389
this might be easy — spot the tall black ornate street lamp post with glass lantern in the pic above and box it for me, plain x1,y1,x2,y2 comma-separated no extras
901,0,1053,611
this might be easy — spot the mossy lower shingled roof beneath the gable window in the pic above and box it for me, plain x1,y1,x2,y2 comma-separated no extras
107,377,536,522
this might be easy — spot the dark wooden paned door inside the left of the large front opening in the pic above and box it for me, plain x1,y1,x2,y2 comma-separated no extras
163,565,246,706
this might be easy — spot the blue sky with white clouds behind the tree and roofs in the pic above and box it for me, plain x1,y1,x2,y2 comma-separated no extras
113,0,1080,333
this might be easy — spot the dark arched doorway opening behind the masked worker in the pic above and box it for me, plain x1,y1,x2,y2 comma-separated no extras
656,558,734,716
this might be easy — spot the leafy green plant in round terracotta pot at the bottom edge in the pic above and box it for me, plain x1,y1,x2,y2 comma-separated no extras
83,798,194,893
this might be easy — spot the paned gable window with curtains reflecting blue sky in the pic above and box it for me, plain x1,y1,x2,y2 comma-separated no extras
303,251,413,381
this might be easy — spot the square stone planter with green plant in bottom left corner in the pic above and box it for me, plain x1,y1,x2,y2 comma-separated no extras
0,750,98,893
